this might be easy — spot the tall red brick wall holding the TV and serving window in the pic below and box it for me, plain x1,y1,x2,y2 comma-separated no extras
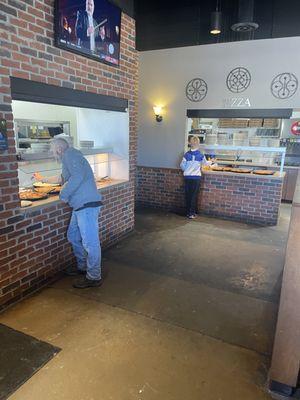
0,0,138,308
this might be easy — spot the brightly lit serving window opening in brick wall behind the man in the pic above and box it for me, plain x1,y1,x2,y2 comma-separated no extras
12,100,129,194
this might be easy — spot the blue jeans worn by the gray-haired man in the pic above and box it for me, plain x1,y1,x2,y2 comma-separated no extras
67,207,101,280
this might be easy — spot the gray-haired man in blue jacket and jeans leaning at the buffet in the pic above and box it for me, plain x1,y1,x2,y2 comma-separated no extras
36,137,103,289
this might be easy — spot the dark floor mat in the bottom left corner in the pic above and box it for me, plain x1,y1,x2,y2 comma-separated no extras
0,324,60,400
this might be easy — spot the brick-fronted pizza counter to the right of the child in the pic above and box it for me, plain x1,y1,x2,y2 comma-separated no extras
198,169,285,225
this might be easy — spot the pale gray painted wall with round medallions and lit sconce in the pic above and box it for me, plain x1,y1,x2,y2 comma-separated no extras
138,37,300,167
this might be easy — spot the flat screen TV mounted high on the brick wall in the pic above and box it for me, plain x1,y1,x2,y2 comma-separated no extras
55,0,121,65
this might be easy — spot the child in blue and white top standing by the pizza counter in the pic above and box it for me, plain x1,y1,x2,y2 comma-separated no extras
180,136,212,219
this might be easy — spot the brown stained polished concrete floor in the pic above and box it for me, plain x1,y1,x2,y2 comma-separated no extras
0,205,290,400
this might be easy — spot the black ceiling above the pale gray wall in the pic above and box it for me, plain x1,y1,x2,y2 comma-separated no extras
135,0,300,51
